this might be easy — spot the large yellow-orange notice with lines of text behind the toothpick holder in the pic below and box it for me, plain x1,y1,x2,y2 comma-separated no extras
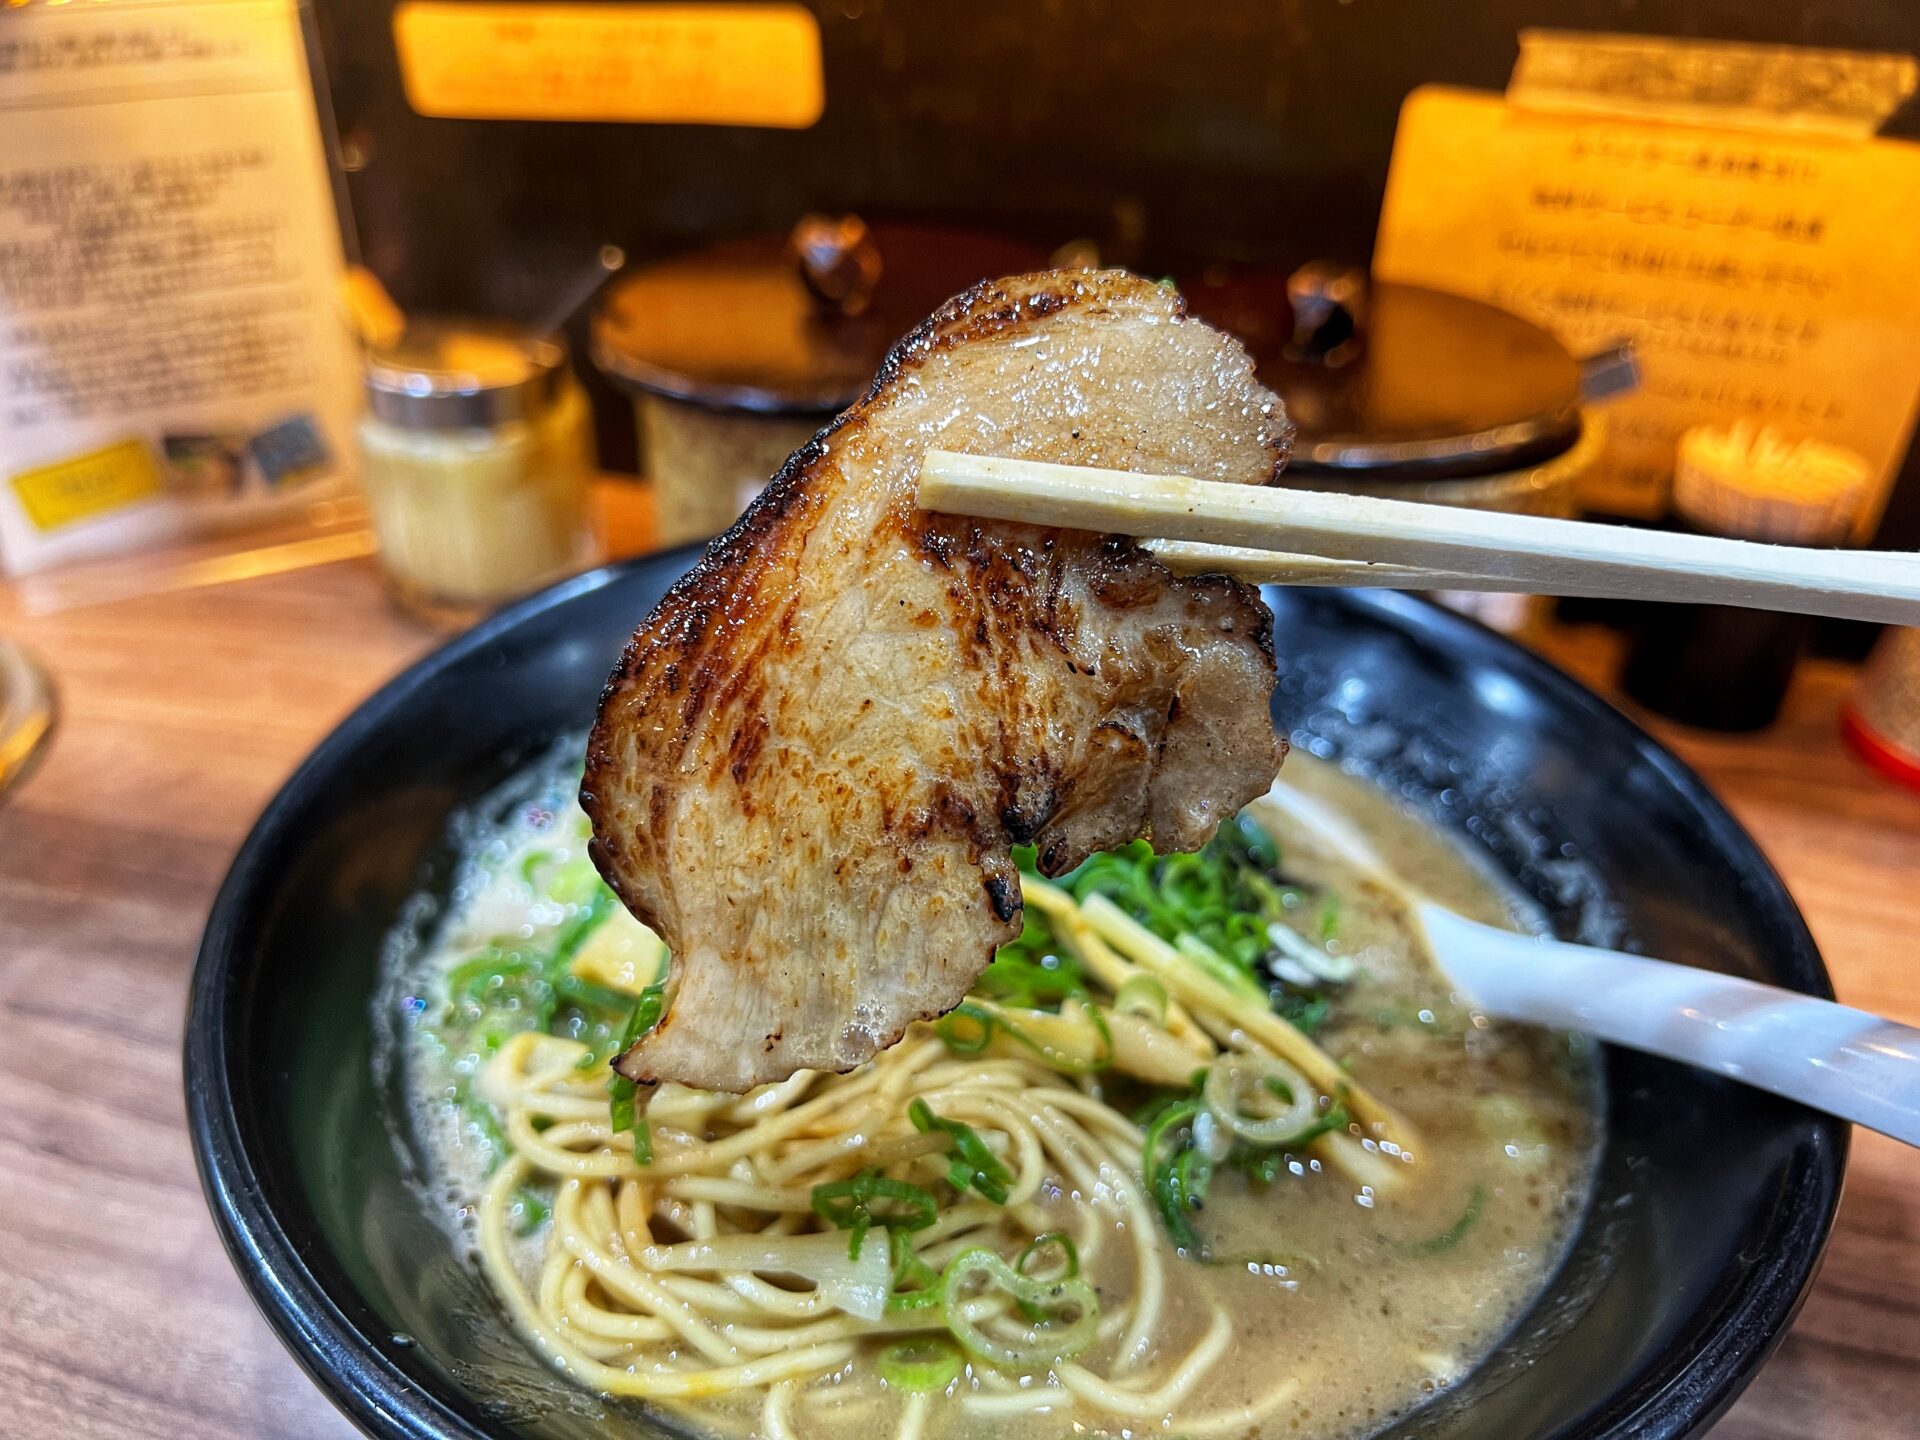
1375,86,1920,530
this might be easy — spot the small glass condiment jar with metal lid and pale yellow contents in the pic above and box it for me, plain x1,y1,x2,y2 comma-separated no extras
359,319,593,624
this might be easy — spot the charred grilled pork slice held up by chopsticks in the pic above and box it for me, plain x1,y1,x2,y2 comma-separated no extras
582,271,1286,1091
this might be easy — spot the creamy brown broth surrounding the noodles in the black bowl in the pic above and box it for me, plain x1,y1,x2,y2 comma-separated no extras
394,755,1597,1440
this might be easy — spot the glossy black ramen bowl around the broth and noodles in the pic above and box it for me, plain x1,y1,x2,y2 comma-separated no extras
186,551,1847,1440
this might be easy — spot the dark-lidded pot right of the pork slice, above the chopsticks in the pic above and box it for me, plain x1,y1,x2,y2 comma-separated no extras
1181,265,1638,515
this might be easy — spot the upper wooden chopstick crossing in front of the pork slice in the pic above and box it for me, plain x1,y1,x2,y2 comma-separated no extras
920,449,1920,624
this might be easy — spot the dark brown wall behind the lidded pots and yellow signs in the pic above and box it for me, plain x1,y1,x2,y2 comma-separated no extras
313,0,1920,545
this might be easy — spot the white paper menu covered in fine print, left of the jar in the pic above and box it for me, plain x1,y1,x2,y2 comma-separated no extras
0,0,357,572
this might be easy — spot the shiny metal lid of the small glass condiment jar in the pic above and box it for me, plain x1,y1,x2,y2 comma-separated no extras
365,319,566,430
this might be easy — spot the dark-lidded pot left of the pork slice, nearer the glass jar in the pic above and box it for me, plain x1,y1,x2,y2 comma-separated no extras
593,215,1046,543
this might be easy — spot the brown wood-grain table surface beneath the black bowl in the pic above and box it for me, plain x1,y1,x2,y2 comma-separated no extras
0,533,1920,1440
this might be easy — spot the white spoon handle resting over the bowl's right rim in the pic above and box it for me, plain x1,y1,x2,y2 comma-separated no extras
1415,900,1920,1146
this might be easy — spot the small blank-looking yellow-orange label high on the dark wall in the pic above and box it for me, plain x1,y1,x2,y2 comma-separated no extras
394,0,826,129
